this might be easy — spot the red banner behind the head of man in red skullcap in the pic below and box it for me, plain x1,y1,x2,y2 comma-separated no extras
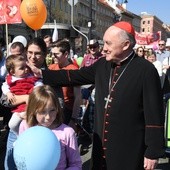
135,31,161,45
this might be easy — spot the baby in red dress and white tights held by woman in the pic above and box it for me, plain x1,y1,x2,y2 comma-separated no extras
2,55,42,134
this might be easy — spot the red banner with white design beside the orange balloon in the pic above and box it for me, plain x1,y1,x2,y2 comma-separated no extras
0,0,22,24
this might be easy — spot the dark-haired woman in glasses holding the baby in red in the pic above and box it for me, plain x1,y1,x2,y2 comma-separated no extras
4,37,63,170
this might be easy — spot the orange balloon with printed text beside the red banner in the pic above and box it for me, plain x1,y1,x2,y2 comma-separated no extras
20,0,47,30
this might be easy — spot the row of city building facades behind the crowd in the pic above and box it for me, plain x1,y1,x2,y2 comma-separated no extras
1,0,170,50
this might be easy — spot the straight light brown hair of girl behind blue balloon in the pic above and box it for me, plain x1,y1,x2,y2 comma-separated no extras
26,85,62,127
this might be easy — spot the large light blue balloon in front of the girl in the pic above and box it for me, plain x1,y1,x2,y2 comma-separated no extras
14,126,61,170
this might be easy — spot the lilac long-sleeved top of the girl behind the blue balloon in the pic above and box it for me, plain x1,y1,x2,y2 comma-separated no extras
19,120,82,170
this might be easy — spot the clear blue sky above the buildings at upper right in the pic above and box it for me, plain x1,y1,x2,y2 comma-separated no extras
126,0,170,24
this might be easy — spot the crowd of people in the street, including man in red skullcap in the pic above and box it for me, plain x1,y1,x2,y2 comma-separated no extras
0,21,170,170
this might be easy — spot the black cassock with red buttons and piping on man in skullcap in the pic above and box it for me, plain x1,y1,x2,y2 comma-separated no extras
43,53,164,170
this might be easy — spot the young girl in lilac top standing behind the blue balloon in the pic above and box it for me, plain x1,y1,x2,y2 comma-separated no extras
19,85,82,170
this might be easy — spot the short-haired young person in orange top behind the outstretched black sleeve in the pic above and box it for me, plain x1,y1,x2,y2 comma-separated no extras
49,39,81,124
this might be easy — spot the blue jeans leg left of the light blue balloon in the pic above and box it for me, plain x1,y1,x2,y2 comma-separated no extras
4,130,17,170
